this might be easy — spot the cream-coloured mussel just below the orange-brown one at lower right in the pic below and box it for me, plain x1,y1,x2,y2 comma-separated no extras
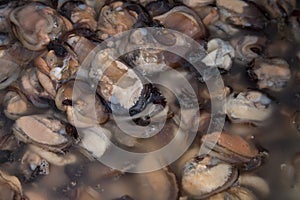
181,156,238,199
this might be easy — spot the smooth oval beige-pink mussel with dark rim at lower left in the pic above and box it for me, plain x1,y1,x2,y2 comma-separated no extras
13,115,73,153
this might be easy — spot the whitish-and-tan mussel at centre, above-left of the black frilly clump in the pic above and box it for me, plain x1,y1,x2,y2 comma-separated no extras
89,49,143,109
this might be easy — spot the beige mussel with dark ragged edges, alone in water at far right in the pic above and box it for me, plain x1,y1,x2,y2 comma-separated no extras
249,58,291,91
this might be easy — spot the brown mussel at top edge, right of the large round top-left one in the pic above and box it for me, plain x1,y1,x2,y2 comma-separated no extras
60,1,97,31
